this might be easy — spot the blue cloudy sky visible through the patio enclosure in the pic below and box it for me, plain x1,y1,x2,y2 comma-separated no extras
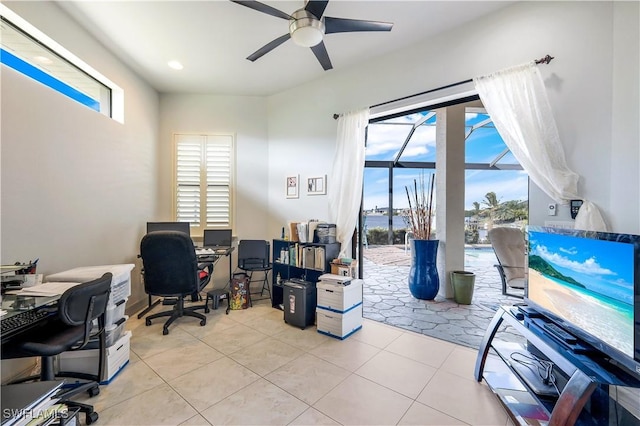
364,112,528,210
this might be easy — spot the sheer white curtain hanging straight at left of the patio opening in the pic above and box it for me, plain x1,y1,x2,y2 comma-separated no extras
327,108,369,257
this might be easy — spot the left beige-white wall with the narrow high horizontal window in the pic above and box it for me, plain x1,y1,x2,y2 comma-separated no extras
1,2,159,316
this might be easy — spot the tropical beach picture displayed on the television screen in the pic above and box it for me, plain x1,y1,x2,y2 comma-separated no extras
528,231,634,357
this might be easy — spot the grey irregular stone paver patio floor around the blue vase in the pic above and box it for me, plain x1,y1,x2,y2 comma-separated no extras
363,246,524,348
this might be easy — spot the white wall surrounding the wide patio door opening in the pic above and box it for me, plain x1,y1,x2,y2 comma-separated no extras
269,2,640,234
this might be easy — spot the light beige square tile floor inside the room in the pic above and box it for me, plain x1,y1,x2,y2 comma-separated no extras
76,301,511,426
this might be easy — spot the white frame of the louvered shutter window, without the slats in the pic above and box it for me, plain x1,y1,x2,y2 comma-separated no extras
172,132,236,237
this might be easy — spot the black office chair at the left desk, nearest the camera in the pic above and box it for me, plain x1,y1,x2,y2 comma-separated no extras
2,273,112,424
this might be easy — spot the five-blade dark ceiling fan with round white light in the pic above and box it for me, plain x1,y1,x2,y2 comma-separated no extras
231,0,393,71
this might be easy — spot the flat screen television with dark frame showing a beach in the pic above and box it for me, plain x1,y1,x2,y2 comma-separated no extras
525,226,640,378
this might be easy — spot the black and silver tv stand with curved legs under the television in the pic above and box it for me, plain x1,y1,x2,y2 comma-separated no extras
474,306,640,425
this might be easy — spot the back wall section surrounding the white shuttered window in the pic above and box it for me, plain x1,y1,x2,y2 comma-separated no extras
158,94,273,285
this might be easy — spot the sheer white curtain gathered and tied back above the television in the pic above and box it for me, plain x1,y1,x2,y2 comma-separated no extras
473,61,607,231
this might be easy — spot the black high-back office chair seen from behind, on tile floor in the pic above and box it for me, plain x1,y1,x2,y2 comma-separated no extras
140,231,211,335
